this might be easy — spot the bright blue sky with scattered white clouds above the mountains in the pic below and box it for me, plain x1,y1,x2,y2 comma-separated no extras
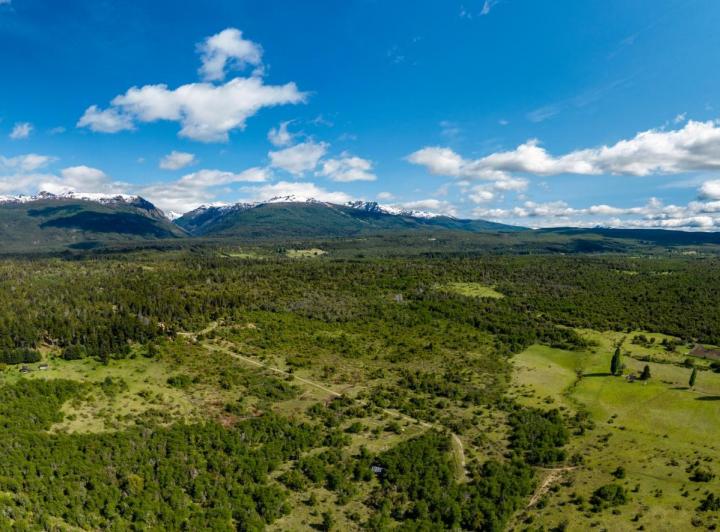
0,0,720,230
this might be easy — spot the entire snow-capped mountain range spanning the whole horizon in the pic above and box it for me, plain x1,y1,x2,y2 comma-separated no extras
0,192,720,252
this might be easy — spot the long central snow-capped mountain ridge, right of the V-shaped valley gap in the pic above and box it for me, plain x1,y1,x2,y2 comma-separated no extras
175,196,523,238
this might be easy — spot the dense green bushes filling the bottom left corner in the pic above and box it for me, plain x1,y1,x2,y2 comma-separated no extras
0,381,323,530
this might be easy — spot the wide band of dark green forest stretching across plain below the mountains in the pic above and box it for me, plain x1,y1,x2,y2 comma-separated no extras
0,249,720,357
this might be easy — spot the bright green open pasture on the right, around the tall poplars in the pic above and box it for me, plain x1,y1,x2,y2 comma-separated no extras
514,331,720,530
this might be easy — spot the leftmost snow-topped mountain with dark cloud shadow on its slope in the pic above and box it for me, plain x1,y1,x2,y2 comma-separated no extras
0,192,186,251
